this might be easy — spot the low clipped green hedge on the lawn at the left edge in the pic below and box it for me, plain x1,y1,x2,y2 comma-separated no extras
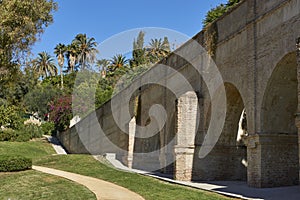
0,155,32,172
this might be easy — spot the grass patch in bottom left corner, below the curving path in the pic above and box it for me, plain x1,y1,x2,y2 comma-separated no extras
0,170,96,200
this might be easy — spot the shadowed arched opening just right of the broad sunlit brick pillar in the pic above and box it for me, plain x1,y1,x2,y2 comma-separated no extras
193,83,247,181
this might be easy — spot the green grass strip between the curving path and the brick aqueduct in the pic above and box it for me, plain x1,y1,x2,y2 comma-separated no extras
34,155,233,200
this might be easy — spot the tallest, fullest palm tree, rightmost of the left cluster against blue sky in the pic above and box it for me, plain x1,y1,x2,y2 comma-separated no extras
72,34,98,69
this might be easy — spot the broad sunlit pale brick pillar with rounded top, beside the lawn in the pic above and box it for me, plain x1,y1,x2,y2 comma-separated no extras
174,92,198,181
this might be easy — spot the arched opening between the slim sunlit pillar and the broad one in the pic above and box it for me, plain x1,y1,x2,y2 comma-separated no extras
132,85,176,174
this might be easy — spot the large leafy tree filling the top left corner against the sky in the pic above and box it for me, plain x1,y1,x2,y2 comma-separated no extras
0,0,57,75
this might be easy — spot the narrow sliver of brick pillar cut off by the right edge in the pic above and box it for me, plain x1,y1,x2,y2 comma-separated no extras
295,37,300,184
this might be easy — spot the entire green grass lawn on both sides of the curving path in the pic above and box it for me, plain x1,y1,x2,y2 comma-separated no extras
0,139,233,200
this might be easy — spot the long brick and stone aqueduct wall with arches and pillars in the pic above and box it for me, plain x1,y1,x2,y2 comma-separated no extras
59,0,300,187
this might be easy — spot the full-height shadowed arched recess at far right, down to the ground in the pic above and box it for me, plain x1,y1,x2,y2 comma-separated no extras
257,52,299,187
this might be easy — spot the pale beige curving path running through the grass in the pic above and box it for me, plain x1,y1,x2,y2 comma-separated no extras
32,166,144,200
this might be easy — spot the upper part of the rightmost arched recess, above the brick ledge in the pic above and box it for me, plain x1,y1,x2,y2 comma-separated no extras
261,52,298,134
